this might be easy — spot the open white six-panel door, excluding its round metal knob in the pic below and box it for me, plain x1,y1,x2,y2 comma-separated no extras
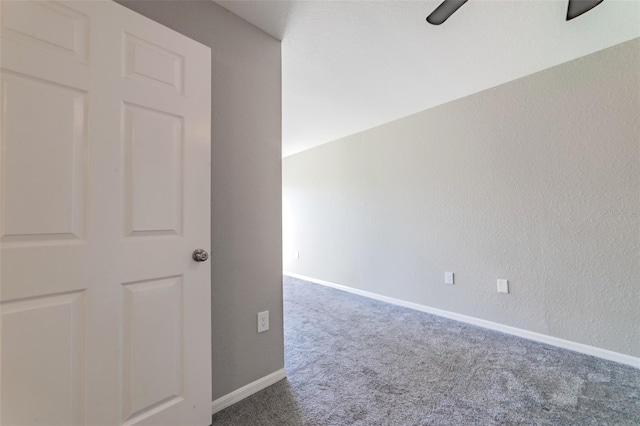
0,1,211,426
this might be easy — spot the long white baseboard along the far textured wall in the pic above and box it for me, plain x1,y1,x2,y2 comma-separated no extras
284,271,640,368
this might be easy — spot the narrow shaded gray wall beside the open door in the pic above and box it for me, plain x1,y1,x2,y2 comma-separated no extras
118,0,284,399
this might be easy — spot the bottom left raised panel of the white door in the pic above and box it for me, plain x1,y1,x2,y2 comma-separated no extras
0,292,85,426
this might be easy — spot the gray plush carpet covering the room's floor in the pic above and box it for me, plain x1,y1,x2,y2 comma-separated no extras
213,277,640,426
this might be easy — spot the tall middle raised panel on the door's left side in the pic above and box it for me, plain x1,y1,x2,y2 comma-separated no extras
2,72,87,245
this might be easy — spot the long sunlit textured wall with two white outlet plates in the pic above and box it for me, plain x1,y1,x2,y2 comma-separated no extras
283,39,640,356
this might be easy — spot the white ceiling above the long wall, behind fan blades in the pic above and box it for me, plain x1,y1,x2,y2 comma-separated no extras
217,0,640,156
